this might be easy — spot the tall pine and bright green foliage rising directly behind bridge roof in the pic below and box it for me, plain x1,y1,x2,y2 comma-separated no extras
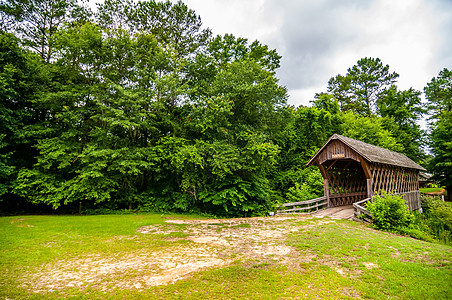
326,58,426,163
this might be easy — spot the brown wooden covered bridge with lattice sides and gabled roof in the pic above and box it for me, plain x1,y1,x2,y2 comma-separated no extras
306,134,425,210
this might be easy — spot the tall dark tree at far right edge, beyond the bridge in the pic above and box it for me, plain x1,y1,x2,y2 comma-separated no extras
424,68,452,201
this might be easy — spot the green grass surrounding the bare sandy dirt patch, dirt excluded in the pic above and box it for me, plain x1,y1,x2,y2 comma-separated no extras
0,214,452,299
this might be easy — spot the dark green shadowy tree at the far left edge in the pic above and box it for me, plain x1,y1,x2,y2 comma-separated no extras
0,33,46,202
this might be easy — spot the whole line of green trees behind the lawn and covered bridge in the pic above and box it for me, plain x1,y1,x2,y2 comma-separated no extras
0,0,450,216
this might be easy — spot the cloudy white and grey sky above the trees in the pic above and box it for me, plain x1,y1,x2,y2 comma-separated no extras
176,0,452,106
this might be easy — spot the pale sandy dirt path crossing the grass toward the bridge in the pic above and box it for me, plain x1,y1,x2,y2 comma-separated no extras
24,215,334,292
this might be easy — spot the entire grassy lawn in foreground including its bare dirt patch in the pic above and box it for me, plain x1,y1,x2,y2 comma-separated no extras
0,214,452,299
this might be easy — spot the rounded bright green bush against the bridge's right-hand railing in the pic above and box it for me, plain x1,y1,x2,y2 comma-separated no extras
367,191,413,231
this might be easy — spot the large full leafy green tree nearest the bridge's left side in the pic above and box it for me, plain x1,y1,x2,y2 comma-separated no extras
180,35,286,216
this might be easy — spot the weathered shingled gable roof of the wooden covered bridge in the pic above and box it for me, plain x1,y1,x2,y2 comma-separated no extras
306,134,426,171
